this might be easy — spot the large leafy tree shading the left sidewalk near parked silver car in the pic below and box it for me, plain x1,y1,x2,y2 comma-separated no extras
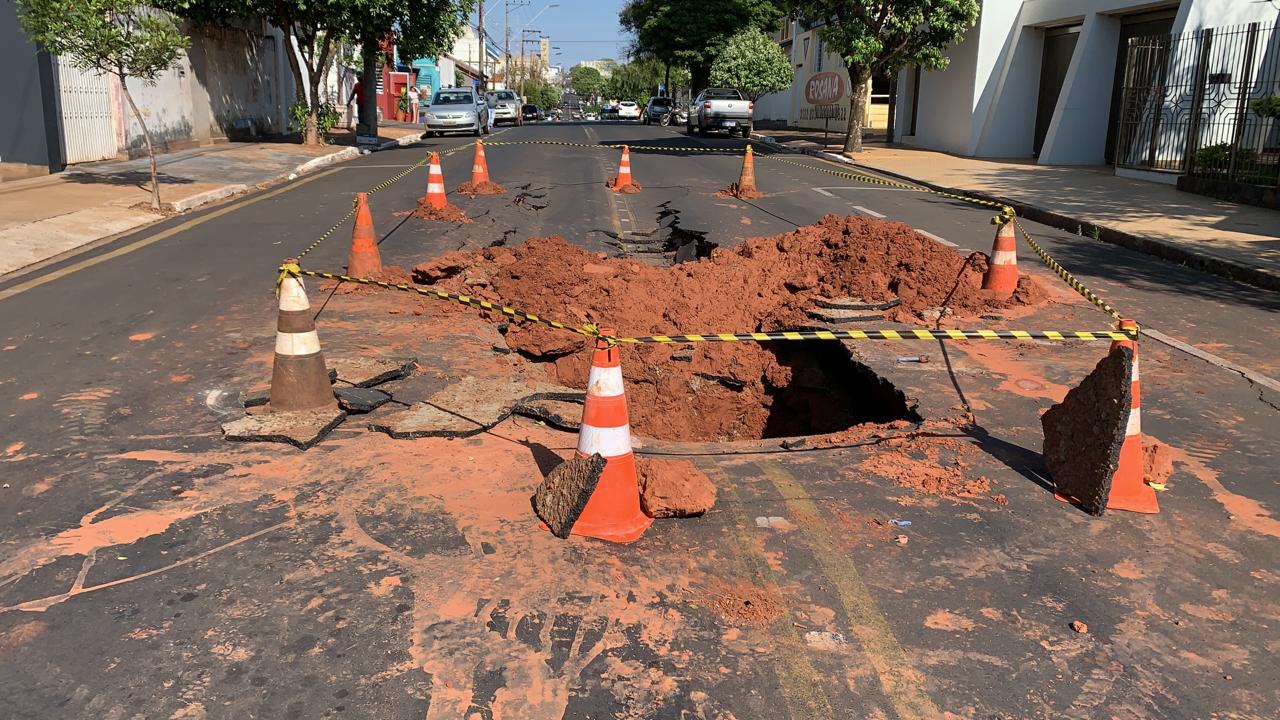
167,0,474,145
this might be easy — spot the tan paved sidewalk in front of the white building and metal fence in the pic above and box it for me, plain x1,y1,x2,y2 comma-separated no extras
756,129,1280,290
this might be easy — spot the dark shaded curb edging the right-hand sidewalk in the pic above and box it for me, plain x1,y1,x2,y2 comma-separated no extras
751,133,1280,291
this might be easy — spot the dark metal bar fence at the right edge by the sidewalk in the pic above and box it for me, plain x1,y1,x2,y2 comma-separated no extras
1116,23,1280,186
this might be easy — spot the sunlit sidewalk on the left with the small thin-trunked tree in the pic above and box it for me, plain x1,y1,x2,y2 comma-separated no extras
0,126,421,275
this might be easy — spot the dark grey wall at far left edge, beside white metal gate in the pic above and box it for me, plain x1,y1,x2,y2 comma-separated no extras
0,3,61,179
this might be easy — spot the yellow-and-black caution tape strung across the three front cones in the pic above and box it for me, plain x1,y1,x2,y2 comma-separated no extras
279,263,1137,345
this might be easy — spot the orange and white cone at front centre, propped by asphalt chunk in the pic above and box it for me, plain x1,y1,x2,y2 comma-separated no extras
572,329,653,542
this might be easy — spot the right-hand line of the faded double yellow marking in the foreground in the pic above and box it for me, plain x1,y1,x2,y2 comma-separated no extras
752,461,940,720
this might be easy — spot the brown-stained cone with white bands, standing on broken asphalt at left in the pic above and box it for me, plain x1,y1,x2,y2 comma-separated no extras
270,260,338,413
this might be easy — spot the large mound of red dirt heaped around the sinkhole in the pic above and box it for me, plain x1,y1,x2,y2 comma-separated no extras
413,215,1047,439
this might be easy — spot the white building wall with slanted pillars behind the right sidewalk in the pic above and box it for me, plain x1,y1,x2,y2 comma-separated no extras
896,0,1280,164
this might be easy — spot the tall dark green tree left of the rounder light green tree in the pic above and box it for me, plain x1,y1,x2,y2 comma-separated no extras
618,0,783,91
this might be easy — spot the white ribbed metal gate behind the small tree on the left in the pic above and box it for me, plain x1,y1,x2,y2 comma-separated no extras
58,56,115,165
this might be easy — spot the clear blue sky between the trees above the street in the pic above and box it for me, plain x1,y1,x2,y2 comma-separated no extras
472,0,628,68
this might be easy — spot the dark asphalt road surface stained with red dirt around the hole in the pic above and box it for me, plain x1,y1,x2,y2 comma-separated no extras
0,123,1280,720
